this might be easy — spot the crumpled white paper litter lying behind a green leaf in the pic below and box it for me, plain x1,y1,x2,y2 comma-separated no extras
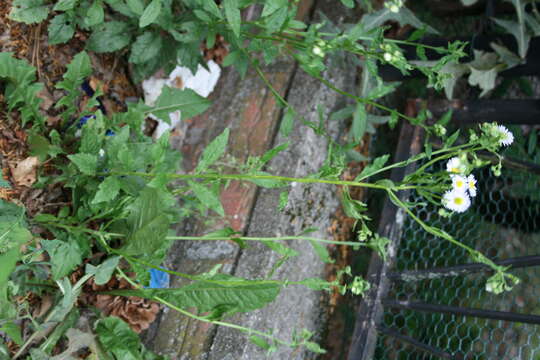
142,60,221,139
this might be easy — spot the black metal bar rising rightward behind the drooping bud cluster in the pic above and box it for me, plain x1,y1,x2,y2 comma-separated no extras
387,255,540,281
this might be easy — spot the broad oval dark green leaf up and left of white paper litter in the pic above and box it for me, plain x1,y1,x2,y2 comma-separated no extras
86,21,131,53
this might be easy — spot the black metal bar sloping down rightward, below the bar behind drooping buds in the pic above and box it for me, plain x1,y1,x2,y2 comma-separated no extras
382,300,540,325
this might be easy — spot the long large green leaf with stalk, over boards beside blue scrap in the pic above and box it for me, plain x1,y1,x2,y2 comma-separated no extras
114,274,281,315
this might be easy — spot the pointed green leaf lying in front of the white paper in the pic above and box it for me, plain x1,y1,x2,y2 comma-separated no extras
151,86,210,124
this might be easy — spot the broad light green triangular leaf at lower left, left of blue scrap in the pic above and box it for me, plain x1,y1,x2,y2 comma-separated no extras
41,239,82,280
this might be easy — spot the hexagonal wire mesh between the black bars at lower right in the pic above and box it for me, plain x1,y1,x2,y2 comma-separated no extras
374,164,540,360
